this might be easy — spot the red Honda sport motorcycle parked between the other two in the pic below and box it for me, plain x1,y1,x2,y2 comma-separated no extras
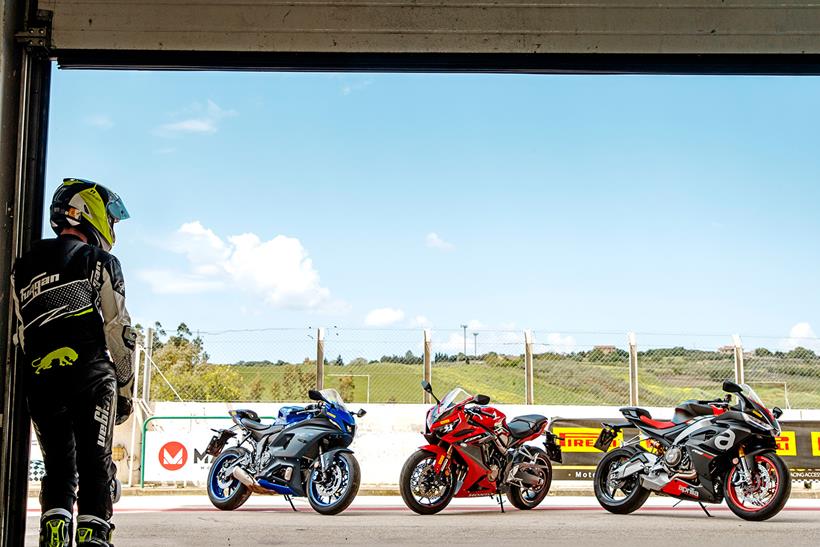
399,382,561,515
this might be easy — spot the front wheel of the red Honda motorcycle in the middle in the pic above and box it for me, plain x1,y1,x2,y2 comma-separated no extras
399,450,455,515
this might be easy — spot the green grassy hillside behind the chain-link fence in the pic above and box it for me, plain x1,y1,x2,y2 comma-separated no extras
223,356,820,408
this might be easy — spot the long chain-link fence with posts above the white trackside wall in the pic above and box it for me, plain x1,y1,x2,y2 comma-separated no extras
148,327,820,408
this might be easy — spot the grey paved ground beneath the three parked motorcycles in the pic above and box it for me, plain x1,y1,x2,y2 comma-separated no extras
26,496,820,547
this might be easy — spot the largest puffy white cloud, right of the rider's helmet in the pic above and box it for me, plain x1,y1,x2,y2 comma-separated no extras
140,221,340,311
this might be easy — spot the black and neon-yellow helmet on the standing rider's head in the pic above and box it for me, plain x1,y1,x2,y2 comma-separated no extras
51,179,129,251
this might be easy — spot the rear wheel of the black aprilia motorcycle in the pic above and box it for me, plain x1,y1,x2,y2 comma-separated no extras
593,448,650,515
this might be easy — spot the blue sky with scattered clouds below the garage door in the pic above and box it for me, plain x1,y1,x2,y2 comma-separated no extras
47,70,820,360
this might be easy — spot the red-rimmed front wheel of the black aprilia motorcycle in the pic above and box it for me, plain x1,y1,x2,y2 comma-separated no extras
723,452,792,520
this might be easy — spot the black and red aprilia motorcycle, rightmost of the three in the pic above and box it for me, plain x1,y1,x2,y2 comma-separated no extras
594,380,791,520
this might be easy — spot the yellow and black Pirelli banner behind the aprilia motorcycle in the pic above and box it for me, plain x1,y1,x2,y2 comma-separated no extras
552,419,820,481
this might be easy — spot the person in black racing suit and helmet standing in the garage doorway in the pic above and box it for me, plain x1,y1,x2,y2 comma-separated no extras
12,179,136,546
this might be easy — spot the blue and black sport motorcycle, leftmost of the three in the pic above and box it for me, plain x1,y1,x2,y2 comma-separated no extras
205,389,365,515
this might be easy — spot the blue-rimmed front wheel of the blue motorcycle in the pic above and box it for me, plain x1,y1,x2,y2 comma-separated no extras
307,452,362,515
